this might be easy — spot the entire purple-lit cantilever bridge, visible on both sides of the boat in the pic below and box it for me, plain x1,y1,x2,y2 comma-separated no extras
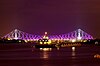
3,29,93,40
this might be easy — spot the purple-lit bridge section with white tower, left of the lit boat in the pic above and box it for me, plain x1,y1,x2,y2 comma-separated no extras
3,29,41,41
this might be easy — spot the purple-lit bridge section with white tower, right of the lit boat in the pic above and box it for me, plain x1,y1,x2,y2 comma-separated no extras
49,29,93,40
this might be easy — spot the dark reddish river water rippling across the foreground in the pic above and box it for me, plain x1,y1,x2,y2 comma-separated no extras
0,44,100,66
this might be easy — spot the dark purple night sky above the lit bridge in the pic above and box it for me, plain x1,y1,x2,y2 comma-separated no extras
0,0,100,38
